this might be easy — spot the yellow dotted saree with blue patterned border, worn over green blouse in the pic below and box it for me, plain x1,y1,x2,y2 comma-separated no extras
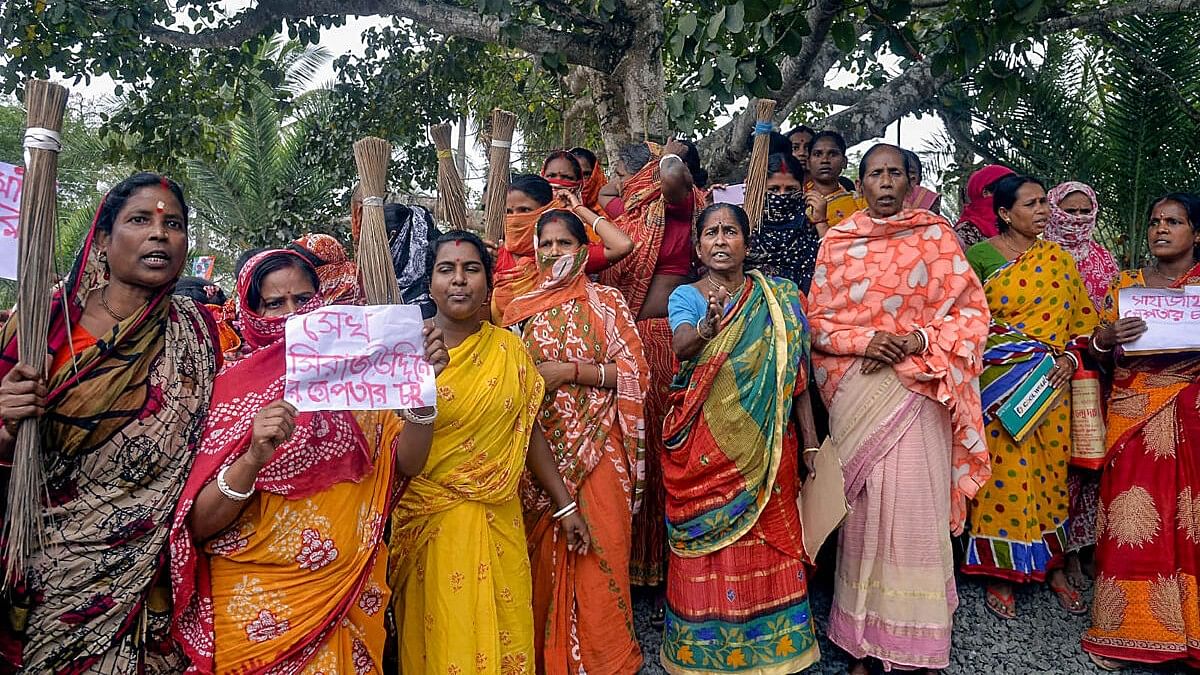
962,239,1097,583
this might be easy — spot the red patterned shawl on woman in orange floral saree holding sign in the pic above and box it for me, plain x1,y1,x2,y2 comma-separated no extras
170,250,372,664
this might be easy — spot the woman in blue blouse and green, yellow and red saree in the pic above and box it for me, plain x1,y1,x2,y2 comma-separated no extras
661,204,821,675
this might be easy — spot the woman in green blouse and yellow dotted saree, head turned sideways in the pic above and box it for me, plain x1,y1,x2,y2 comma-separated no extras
962,175,1097,619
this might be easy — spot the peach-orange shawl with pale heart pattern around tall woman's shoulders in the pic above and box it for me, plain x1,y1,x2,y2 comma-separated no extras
809,210,991,531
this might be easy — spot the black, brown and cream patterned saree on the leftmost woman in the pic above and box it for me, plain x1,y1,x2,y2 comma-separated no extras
0,193,221,675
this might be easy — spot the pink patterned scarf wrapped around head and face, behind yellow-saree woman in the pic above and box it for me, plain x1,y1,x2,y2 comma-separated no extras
1044,181,1121,310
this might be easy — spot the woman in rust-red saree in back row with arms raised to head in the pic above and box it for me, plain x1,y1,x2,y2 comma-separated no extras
600,142,704,588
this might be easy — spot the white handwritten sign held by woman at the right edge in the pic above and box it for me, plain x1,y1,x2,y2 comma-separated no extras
1117,286,1200,353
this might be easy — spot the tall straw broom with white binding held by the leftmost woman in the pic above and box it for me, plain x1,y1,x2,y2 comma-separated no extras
4,79,67,589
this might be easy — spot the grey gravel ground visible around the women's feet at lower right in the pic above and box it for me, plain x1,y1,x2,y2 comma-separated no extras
634,566,1189,675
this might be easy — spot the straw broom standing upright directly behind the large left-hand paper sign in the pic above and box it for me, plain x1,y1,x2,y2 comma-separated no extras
354,136,401,305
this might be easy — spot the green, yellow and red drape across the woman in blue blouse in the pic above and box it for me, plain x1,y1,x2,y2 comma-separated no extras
662,270,809,557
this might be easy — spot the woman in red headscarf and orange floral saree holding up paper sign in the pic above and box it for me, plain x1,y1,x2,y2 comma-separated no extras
172,250,446,673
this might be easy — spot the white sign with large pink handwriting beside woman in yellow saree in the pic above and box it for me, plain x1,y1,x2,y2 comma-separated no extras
283,305,437,411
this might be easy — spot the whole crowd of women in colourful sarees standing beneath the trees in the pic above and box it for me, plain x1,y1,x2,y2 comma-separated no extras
0,127,1200,675
